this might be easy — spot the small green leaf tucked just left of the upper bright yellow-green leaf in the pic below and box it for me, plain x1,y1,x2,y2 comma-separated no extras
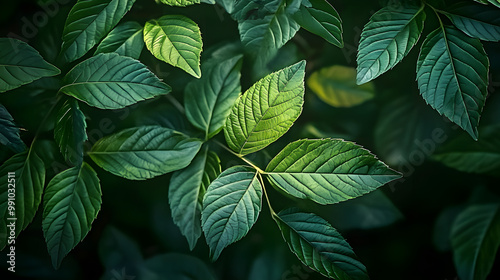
94,21,144,59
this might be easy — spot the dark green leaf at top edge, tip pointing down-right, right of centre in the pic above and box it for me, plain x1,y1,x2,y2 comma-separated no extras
293,0,344,48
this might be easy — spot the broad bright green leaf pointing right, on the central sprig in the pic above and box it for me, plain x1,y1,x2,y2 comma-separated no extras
266,139,401,204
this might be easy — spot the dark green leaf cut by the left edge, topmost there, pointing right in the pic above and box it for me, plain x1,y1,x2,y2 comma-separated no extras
0,38,61,93
